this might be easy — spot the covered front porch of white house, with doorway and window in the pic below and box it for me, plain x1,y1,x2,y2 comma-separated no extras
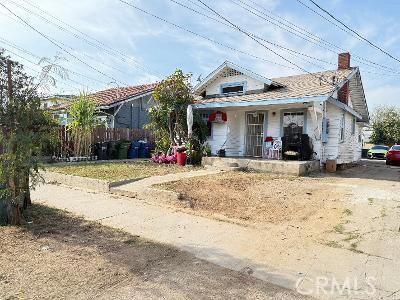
195,97,326,162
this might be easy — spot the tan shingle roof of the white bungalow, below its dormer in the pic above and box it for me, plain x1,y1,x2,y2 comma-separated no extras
196,69,353,103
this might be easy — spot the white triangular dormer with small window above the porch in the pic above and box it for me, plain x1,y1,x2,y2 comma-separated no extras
194,61,281,98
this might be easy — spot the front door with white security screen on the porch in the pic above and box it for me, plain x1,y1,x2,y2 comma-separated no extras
246,112,264,157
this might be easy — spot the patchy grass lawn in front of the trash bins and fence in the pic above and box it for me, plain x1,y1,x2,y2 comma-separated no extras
48,161,195,181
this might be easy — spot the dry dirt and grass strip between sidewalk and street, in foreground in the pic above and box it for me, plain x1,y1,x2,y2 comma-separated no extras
0,205,310,299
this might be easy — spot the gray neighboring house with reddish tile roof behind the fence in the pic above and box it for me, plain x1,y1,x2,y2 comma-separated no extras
90,83,157,129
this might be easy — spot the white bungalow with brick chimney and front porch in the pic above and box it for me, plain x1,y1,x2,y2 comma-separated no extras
193,53,369,164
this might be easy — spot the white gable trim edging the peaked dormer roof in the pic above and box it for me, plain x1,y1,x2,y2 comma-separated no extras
194,61,282,95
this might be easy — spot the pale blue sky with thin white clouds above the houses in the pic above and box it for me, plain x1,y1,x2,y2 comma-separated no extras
0,0,400,110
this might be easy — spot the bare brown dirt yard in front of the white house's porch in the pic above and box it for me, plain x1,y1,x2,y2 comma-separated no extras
159,172,348,224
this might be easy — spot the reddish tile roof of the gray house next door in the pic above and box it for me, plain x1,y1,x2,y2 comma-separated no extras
90,83,158,106
